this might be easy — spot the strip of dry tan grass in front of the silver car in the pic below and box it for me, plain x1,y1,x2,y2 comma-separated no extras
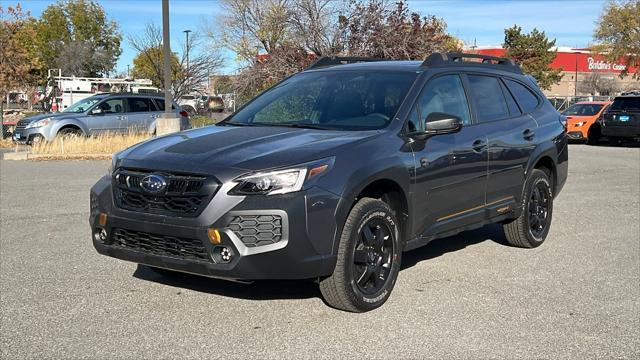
31,133,149,158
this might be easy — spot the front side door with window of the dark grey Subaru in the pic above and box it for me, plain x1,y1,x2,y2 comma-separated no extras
407,74,488,236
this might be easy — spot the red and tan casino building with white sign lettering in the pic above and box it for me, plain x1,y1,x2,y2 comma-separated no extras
475,47,640,96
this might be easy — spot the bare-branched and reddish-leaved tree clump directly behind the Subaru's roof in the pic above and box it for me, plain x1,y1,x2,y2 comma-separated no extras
219,0,461,100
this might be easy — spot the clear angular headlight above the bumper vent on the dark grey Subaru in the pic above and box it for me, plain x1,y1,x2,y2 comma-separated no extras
229,157,334,195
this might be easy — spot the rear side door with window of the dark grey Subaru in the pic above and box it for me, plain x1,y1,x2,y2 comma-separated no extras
467,74,539,217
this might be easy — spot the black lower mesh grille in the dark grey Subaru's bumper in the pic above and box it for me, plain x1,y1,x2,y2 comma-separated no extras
112,228,211,261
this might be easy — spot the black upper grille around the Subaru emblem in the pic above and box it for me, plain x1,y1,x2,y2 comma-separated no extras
113,169,218,217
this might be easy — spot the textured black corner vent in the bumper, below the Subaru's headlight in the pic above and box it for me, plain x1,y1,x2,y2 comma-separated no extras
228,215,282,247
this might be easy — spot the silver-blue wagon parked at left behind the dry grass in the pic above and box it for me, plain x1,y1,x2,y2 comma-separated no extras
13,94,191,144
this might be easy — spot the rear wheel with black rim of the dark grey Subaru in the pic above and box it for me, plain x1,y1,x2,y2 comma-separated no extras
503,169,553,248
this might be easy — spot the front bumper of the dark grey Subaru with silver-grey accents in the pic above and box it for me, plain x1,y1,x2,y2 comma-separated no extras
89,177,340,280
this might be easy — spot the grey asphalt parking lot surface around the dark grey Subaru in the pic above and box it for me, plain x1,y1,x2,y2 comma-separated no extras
0,145,640,359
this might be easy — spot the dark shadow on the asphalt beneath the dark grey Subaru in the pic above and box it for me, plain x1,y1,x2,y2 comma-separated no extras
133,224,508,300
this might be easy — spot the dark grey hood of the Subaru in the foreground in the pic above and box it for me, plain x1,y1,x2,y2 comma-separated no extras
117,126,380,181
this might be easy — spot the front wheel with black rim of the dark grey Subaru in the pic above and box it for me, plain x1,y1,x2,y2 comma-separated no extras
320,198,402,312
